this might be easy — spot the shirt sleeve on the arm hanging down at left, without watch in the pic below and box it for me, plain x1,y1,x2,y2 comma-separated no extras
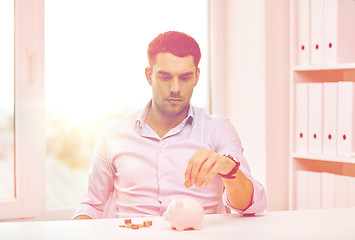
73,126,114,219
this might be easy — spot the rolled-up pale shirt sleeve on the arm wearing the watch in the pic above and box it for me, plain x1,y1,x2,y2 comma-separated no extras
217,120,267,215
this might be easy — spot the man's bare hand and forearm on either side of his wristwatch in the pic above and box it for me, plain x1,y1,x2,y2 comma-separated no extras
185,149,254,210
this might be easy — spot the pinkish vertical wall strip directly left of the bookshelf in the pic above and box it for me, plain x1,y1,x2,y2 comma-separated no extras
265,0,290,210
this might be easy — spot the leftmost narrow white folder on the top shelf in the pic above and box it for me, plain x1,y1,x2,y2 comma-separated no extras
295,0,310,65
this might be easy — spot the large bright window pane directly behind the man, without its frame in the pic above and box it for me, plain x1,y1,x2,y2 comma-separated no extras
45,0,209,213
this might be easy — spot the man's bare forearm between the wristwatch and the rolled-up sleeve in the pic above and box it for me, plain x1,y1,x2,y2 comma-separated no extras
223,170,254,210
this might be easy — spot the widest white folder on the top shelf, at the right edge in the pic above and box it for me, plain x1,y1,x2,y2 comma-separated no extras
323,0,355,64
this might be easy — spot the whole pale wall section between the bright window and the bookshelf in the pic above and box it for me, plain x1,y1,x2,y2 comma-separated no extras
210,0,289,210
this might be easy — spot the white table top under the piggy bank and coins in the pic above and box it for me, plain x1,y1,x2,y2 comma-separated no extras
0,208,355,240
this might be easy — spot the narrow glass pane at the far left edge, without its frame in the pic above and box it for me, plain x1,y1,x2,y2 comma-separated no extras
0,1,15,200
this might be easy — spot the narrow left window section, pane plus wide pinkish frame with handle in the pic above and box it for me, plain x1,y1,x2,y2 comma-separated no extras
0,0,45,219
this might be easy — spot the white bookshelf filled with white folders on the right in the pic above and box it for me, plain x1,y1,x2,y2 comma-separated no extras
289,0,355,210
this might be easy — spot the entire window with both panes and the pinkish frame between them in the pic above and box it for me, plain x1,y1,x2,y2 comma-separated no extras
0,0,209,220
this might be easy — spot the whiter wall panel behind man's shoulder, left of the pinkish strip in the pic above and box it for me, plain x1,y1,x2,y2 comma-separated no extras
228,0,266,188
